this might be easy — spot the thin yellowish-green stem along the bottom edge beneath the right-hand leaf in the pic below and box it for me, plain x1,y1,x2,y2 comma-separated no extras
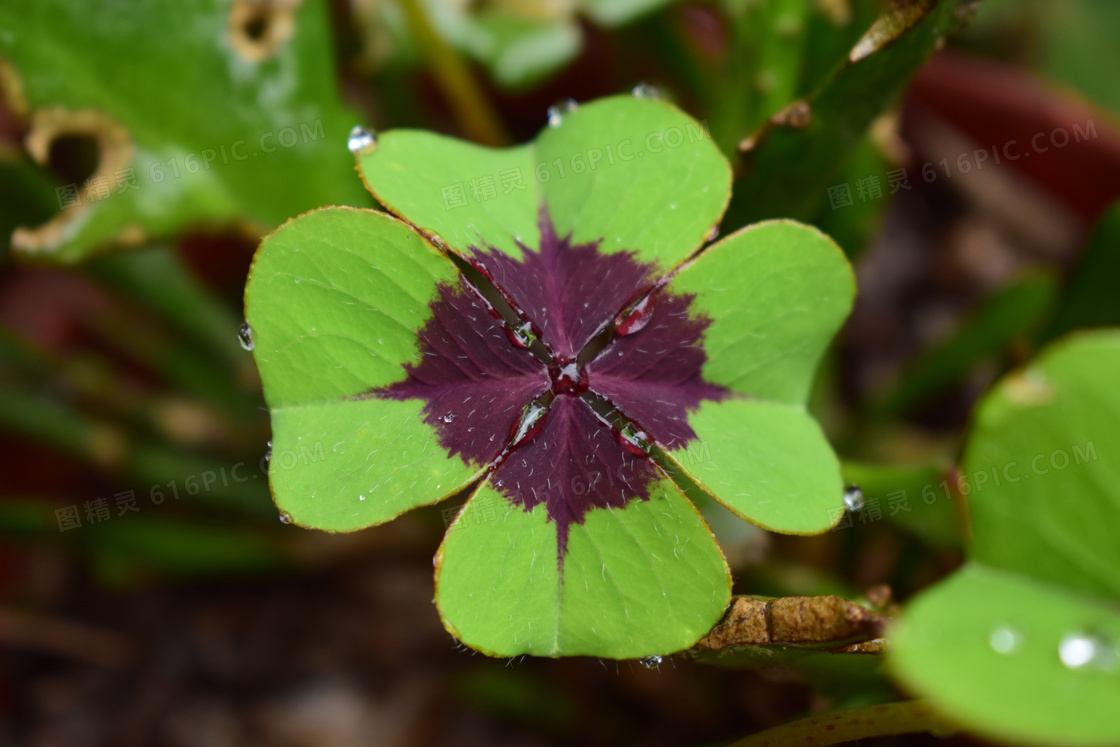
728,700,952,747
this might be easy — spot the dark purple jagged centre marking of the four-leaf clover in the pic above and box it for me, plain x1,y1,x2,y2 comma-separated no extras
368,211,729,559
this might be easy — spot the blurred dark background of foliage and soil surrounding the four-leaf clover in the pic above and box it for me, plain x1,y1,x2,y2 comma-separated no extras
0,0,1120,747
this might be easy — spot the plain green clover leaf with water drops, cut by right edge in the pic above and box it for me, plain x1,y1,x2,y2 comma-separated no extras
889,329,1120,745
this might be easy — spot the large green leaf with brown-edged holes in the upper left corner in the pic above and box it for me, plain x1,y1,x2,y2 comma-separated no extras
0,0,370,262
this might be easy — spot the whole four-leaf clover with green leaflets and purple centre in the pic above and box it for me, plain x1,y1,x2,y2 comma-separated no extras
245,96,855,659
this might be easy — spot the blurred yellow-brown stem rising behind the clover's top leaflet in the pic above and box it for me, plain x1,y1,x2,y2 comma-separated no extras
401,0,510,146
